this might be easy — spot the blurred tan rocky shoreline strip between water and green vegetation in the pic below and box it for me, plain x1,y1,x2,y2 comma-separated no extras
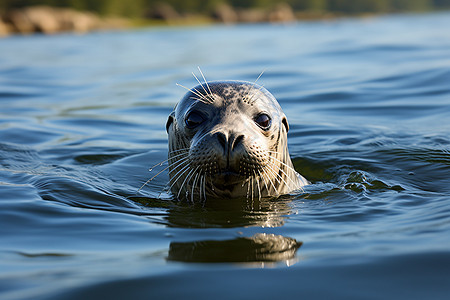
0,3,448,37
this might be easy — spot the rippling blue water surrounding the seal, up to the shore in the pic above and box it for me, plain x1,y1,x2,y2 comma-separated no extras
0,14,450,299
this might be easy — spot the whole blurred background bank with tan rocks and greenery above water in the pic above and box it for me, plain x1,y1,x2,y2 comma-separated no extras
0,0,450,36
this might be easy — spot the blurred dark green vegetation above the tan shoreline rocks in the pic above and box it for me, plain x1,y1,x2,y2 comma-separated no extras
0,0,450,18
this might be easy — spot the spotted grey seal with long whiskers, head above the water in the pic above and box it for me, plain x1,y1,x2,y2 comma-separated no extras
166,81,308,202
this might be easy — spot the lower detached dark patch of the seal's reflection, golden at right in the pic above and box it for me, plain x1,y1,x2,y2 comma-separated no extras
167,233,302,265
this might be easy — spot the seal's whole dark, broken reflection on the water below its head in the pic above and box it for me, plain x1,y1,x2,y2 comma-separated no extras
160,196,302,266
